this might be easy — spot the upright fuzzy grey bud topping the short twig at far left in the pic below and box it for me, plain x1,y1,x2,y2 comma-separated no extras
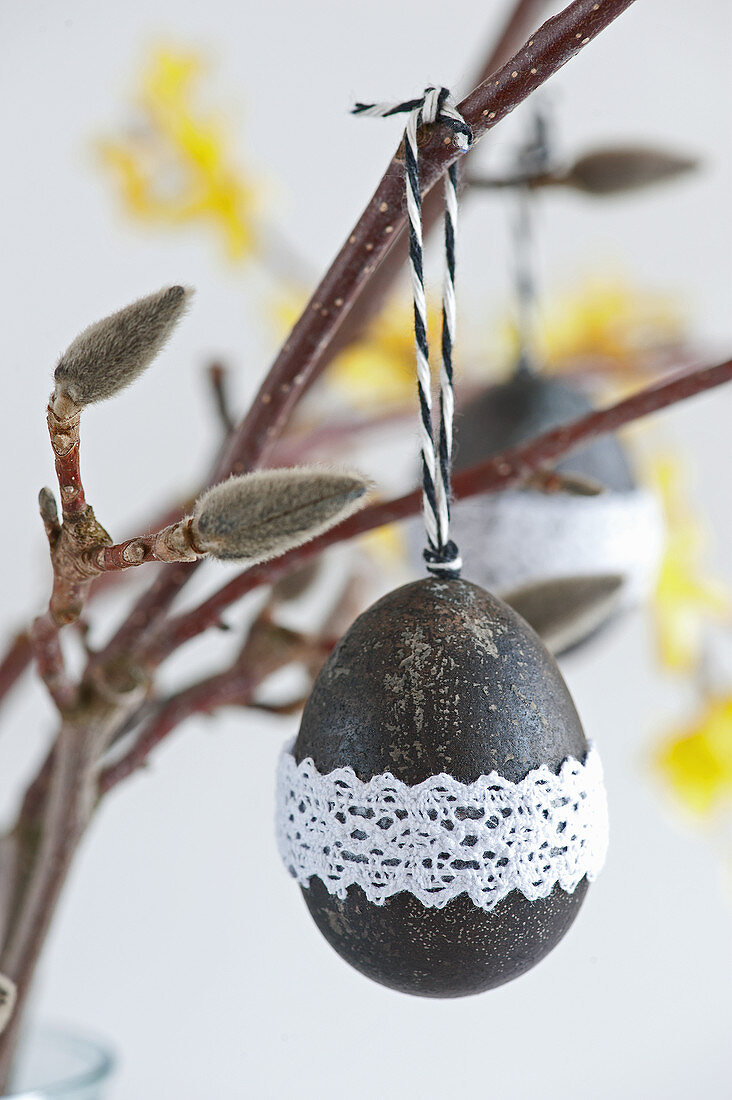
54,286,192,407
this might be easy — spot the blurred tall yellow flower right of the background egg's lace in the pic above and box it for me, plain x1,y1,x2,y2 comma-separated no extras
654,458,730,672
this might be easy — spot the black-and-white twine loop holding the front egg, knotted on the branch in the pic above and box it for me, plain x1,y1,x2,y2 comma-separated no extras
353,87,472,576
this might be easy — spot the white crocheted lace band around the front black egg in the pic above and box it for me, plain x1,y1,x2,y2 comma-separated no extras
277,747,608,911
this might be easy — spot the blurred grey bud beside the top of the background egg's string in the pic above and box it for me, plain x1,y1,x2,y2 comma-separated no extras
561,146,698,195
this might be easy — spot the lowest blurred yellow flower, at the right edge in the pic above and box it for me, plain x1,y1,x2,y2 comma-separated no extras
655,695,732,814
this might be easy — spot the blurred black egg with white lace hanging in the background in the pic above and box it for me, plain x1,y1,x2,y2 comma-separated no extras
444,369,663,641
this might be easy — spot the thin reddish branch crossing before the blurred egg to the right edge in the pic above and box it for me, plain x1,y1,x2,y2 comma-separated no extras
144,360,732,664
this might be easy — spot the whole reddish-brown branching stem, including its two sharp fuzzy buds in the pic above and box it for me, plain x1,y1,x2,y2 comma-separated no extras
5,0,732,1091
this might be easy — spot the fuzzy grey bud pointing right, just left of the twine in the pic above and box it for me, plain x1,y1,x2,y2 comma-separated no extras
192,466,369,564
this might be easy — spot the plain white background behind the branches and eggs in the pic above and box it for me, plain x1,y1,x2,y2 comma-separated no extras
0,0,732,1100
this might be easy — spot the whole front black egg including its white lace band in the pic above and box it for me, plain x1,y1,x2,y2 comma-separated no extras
278,578,604,997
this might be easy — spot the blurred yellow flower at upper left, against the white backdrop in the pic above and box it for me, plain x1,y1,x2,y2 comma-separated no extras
99,47,256,260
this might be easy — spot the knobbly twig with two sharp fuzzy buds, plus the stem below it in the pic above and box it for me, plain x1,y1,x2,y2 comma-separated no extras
0,287,368,1084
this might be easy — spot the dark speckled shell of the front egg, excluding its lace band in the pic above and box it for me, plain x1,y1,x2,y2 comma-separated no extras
294,579,587,997
